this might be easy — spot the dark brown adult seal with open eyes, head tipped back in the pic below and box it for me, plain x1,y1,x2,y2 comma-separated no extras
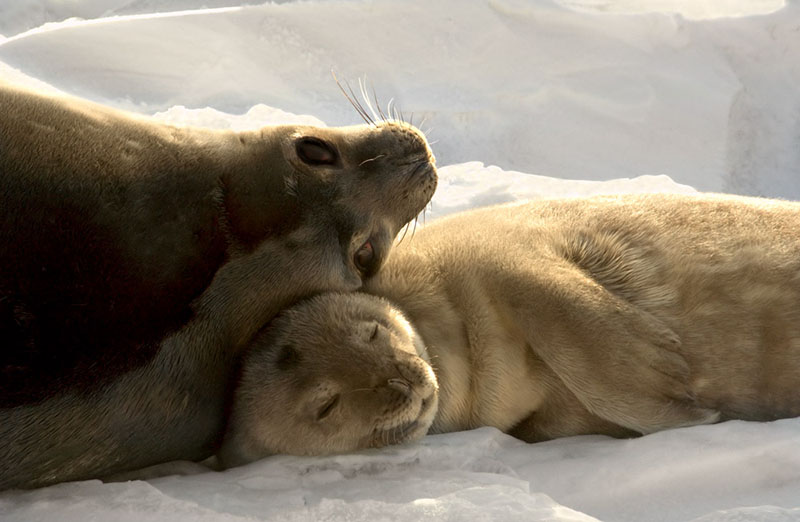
0,85,436,489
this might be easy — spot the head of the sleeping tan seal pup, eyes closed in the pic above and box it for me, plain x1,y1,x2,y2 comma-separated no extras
218,293,439,467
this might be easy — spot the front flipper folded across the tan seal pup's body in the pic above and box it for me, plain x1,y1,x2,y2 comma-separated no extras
502,260,719,433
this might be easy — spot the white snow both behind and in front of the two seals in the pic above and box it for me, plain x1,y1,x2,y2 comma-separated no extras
0,0,800,522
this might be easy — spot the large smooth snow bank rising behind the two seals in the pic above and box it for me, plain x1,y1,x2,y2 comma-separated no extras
0,0,800,199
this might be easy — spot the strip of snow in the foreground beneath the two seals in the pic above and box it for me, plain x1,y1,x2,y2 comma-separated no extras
0,419,800,522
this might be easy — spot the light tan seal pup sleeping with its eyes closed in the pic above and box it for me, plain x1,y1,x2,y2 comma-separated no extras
221,195,800,465
